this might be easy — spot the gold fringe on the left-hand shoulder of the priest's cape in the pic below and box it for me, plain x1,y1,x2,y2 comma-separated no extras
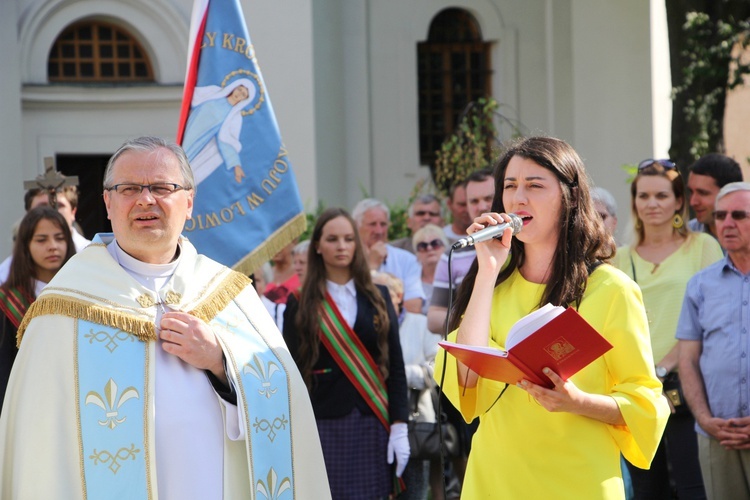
16,294,156,347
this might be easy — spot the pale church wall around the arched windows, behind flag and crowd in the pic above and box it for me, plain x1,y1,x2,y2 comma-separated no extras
0,0,654,253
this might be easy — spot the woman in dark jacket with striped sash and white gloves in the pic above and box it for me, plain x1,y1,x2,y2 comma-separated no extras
284,208,409,500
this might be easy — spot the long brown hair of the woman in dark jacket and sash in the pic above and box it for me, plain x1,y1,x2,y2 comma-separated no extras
295,208,390,389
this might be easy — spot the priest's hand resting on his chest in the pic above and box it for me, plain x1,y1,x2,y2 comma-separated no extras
159,311,228,385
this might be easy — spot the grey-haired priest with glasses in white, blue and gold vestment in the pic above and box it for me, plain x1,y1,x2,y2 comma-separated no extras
0,137,330,500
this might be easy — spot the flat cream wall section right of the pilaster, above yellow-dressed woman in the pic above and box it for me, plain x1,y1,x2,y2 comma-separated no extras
570,0,655,243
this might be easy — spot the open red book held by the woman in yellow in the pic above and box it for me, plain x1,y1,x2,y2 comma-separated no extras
439,304,612,388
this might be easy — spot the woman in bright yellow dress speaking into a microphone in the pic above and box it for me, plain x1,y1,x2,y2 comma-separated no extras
435,137,669,500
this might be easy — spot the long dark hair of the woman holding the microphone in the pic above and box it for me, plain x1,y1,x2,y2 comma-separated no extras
449,137,615,330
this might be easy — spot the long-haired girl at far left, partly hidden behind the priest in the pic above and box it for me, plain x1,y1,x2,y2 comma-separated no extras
0,205,76,409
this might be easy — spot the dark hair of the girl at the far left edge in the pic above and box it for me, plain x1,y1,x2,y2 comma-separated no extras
2,205,76,299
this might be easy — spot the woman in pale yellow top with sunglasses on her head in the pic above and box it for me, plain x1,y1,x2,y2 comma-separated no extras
614,159,723,499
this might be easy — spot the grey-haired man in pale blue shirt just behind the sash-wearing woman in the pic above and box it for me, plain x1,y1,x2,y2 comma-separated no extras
352,198,425,313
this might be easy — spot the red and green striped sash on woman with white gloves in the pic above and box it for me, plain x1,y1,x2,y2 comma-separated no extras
320,292,390,430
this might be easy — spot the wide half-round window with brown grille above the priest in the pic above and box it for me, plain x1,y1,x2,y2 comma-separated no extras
47,20,154,83
